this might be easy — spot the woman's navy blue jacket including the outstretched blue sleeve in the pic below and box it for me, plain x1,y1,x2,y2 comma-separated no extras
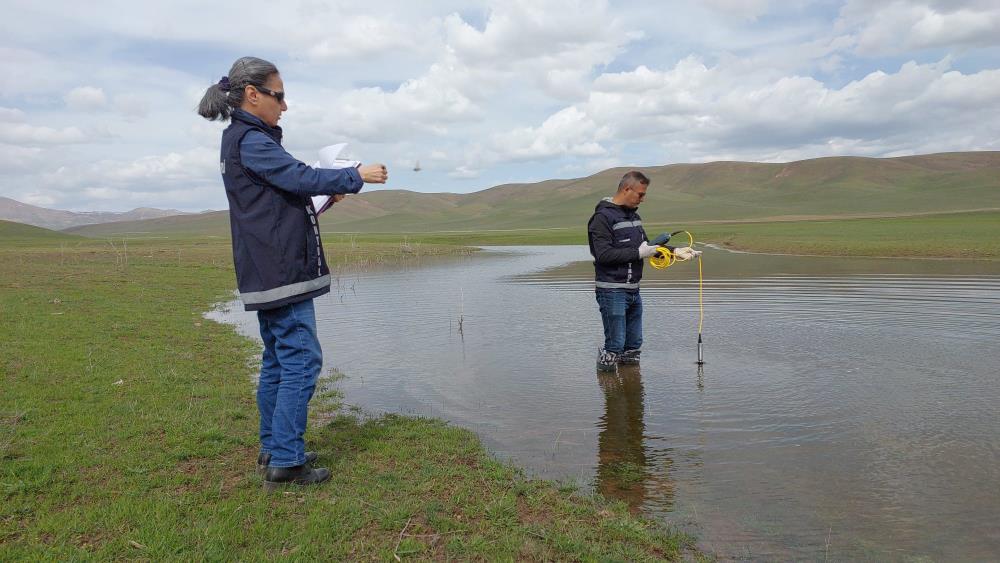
220,109,363,311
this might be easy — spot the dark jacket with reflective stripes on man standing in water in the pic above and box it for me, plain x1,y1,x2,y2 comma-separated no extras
587,198,647,291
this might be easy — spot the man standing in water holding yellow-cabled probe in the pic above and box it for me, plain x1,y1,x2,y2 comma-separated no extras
587,170,701,371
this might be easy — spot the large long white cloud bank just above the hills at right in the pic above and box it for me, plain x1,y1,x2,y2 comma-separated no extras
472,58,1000,169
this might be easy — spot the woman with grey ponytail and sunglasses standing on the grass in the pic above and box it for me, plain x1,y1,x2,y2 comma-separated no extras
198,57,388,490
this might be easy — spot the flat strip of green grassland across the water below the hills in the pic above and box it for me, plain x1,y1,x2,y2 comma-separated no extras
64,206,1000,260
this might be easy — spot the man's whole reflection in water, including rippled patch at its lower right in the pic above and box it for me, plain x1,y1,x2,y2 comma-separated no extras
595,365,674,512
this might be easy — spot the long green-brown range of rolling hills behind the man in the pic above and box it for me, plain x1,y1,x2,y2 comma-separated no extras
69,152,1000,236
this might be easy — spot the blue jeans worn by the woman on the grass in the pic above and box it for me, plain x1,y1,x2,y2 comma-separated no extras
257,299,323,467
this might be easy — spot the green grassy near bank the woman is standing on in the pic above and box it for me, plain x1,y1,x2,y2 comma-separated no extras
0,236,700,561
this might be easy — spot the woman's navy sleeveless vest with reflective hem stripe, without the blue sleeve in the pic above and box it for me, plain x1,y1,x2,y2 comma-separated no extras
221,111,330,311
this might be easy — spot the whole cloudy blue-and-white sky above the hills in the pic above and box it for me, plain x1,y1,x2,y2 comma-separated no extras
0,0,1000,211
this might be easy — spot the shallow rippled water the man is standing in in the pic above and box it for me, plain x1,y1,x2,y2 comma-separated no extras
211,246,1000,560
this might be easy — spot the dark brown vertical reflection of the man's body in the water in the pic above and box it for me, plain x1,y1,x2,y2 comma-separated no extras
597,368,648,510
